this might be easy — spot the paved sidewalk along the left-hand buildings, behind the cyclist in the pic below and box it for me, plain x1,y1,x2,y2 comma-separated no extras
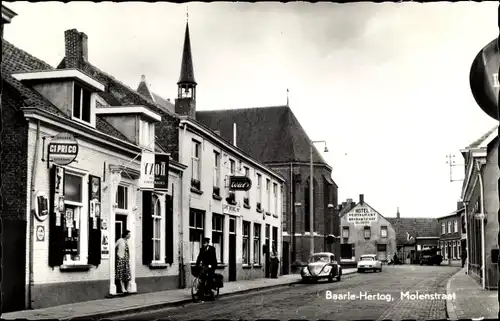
2,269,357,320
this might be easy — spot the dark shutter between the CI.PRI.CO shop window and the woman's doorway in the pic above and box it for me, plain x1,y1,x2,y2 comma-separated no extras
88,175,102,266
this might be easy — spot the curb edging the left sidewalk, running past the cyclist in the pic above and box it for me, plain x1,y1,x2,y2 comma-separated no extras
66,271,357,321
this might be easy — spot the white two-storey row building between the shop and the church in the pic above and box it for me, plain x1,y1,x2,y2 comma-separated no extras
179,117,284,284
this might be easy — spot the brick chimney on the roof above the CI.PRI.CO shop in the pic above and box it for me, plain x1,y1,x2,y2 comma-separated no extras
64,29,88,69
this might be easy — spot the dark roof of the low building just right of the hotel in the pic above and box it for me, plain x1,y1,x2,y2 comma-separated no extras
387,217,439,244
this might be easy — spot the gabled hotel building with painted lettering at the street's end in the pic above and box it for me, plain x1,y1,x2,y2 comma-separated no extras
340,194,396,262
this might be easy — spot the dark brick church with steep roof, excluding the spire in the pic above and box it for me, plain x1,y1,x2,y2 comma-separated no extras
196,105,340,274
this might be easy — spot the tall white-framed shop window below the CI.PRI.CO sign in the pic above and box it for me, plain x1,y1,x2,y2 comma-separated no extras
64,169,88,264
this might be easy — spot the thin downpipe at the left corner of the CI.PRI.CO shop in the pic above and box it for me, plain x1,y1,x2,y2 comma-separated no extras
28,120,40,309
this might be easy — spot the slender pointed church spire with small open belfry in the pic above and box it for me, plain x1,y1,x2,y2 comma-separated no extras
175,18,197,119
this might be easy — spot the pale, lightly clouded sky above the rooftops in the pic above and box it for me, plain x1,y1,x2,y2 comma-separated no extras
4,2,498,217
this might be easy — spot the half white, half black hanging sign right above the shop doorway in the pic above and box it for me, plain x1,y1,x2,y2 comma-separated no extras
139,152,170,192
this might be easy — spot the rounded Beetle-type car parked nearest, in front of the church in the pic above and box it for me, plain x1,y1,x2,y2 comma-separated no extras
300,252,342,282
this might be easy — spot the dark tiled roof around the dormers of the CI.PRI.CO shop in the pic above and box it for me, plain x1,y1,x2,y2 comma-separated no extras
2,39,130,142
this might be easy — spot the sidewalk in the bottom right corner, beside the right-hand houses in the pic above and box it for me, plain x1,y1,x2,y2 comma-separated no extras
446,268,498,320
